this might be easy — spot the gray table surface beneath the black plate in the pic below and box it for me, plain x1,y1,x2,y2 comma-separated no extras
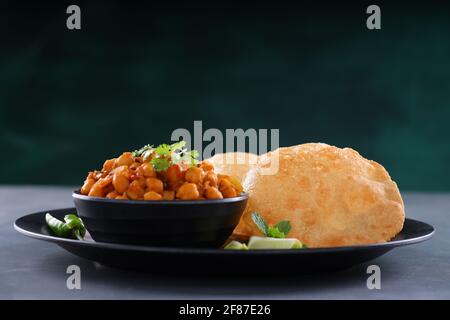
0,186,450,299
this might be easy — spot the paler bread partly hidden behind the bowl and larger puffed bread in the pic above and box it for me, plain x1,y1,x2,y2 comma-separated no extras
207,152,258,182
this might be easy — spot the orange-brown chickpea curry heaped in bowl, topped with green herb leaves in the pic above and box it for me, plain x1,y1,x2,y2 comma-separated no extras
80,141,242,200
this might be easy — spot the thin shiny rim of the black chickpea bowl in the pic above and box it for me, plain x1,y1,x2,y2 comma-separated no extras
72,189,248,205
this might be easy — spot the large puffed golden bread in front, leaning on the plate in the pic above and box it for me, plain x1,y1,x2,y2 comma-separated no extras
234,143,405,247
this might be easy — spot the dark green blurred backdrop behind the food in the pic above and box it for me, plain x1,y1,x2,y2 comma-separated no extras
0,1,450,190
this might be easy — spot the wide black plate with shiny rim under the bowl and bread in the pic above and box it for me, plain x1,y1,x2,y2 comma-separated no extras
14,208,434,275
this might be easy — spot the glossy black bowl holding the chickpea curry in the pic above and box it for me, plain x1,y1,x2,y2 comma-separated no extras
72,191,248,248
